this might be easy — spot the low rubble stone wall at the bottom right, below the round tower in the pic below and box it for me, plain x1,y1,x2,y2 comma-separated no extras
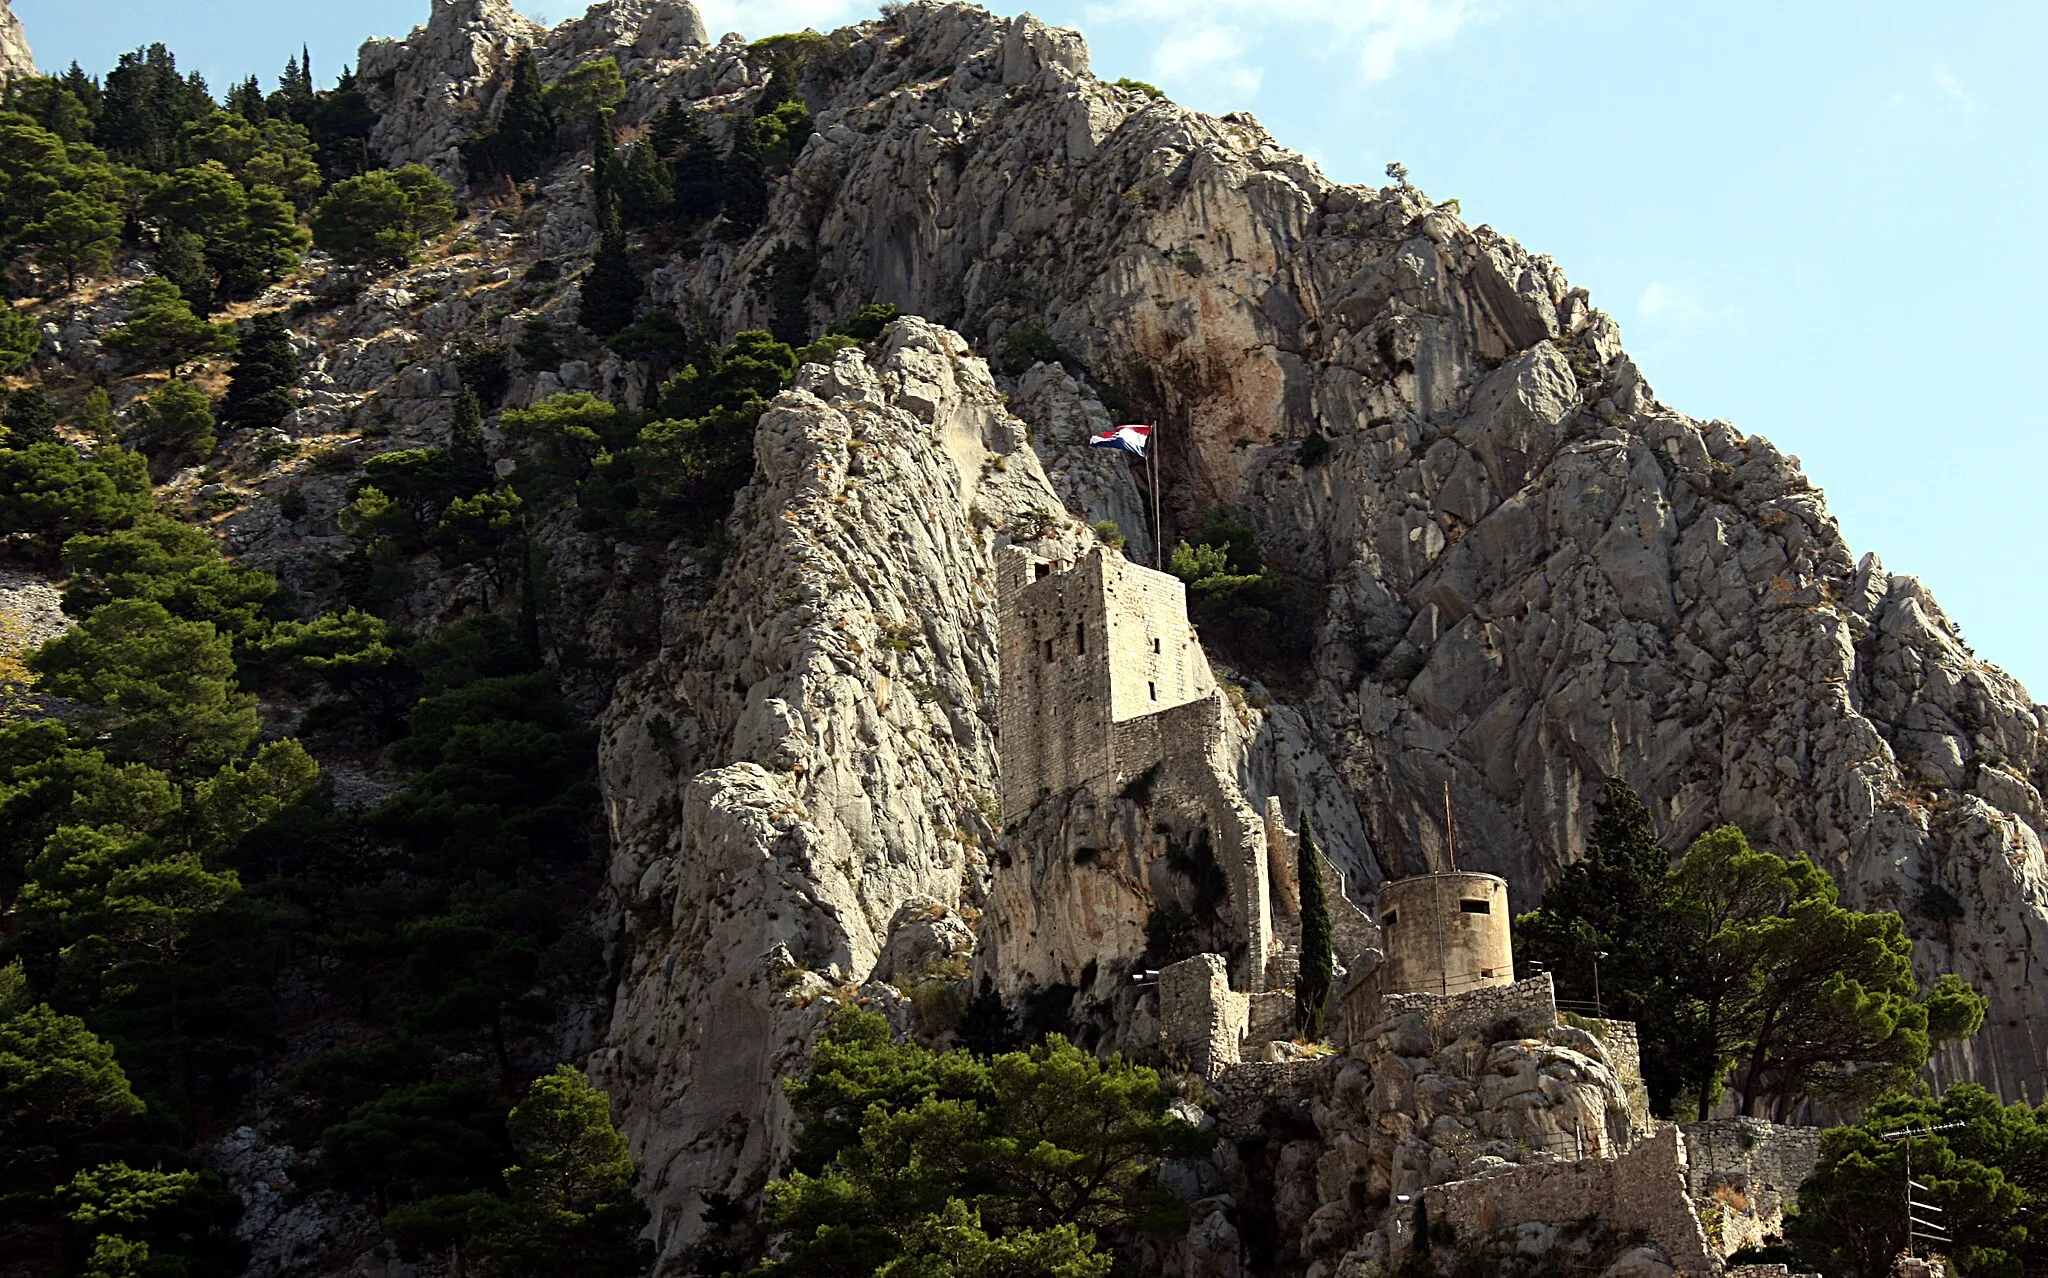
1423,1126,1720,1278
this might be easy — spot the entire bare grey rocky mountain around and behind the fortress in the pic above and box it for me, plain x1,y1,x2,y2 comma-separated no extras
0,0,2048,1272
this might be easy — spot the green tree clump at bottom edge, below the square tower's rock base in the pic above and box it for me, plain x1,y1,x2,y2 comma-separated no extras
756,1010,1210,1278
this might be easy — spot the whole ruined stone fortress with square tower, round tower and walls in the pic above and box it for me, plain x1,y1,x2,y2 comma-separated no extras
979,547,1817,1278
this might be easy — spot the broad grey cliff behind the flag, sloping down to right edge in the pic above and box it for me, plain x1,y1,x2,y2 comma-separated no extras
602,4,2048,1096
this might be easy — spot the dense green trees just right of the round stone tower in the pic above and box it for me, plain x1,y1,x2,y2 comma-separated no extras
1516,780,1985,1116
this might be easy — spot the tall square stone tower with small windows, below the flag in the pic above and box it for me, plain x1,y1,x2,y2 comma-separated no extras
997,547,1221,821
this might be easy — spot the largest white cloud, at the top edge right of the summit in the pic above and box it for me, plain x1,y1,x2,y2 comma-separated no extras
1087,0,1507,94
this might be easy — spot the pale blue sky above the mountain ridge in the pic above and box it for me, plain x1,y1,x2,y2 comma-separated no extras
14,0,2048,696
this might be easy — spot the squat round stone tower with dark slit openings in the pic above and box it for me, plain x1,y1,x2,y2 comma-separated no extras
1380,875,1516,993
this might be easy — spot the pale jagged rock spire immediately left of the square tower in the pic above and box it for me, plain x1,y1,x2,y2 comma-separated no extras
596,320,1083,1253
